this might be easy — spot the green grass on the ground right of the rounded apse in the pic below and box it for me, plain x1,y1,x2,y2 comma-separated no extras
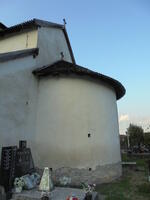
96,155,150,200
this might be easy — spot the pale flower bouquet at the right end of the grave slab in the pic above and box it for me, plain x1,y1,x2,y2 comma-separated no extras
81,183,96,200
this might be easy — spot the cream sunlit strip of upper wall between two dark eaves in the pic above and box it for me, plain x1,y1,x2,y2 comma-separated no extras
0,30,38,53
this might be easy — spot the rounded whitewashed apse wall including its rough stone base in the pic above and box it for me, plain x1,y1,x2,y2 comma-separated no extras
35,76,121,184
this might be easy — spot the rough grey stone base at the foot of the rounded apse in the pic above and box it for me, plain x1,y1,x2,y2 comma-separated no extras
37,162,122,186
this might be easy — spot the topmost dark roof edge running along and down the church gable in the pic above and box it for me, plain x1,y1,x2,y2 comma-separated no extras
0,19,75,63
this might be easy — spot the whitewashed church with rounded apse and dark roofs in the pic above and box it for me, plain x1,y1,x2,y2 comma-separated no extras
0,19,125,184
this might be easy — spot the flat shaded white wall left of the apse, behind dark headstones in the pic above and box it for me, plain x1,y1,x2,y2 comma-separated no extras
0,56,38,153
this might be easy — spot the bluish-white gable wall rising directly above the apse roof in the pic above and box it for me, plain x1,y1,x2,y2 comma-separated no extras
36,27,72,67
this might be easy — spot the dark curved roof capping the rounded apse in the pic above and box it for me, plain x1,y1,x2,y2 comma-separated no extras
33,60,126,100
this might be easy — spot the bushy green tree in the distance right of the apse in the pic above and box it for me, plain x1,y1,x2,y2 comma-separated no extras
126,124,144,148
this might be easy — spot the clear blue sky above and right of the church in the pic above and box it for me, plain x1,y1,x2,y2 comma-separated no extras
0,0,150,133
